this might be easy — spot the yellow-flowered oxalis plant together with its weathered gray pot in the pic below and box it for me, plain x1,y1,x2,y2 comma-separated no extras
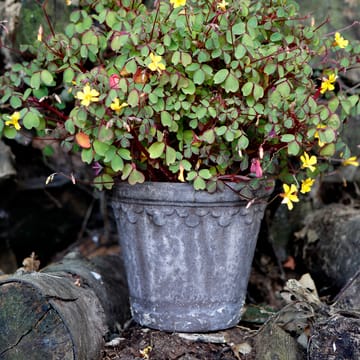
0,0,360,331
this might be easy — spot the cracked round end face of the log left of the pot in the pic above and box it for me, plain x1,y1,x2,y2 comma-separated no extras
0,282,74,360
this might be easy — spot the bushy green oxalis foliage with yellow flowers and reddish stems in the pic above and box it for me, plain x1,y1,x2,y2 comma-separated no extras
0,0,360,209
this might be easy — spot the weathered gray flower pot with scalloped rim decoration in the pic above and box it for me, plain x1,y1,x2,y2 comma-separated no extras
112,183,272,332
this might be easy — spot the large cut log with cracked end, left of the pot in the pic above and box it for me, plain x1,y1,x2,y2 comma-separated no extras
0,253,129,360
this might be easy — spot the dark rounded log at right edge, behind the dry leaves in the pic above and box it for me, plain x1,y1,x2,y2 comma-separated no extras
297,204,360,293
